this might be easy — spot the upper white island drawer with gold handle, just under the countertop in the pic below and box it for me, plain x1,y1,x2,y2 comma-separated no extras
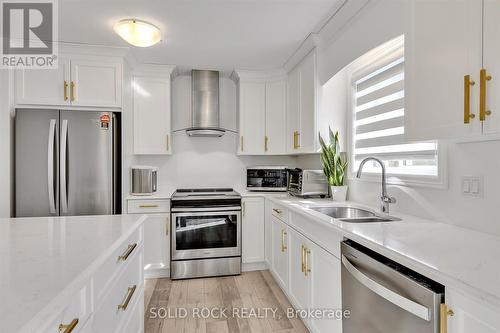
94,226,143,304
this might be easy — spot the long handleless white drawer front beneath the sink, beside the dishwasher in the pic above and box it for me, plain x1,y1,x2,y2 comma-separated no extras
290,213,343,258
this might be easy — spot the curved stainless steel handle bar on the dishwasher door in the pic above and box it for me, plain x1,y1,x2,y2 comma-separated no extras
342,255,431,321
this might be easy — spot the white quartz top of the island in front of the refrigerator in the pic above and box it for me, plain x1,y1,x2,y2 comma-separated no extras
0,215,146,333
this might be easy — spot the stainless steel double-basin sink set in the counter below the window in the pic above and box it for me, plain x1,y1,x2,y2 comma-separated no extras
309,206,401,223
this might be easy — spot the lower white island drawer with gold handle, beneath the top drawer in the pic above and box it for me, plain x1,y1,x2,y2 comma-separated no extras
93,246,144,333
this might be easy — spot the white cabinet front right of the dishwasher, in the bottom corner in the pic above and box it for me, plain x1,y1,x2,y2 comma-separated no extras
446,289,500,333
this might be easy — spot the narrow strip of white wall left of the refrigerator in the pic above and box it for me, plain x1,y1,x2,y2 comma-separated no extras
0,70,14,217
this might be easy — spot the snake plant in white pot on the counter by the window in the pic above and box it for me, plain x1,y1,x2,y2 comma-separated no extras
319,128,347,201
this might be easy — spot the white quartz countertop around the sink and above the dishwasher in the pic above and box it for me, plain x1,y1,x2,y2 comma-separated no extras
266,195,500,306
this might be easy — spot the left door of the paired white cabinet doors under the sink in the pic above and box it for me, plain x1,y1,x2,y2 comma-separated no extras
288,228,311,309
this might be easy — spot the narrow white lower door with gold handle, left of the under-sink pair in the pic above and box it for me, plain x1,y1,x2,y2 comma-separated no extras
271,217,289,290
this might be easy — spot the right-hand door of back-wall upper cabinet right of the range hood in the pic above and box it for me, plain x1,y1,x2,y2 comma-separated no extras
266,80,286,154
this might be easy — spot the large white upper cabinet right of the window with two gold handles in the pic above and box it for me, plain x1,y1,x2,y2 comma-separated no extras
405,0,500,141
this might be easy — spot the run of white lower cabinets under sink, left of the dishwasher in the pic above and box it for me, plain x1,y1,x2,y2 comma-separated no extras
266,198,342,333
